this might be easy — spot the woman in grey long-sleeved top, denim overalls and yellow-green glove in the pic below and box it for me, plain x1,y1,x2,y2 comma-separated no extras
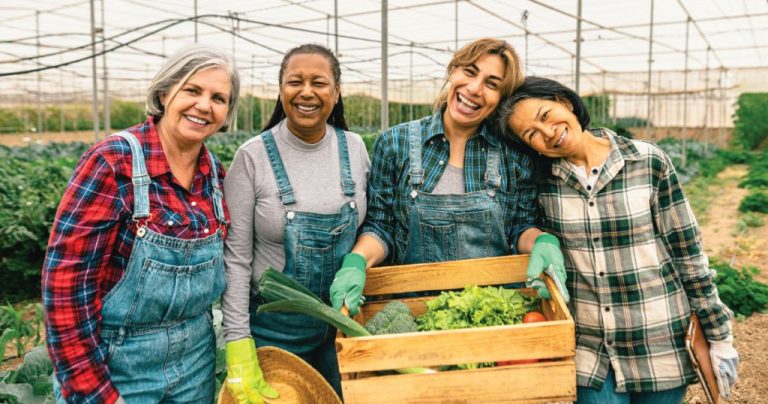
222,44,370,403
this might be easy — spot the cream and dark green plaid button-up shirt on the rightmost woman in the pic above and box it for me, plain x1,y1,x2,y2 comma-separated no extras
539,129,731,392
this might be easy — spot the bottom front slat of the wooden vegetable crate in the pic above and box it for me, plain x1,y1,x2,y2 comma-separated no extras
342,360,576,404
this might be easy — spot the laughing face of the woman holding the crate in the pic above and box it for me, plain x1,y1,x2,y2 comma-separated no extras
443,55,504,130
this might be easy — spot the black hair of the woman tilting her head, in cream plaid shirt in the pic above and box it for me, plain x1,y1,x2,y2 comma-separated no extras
493,76,590,180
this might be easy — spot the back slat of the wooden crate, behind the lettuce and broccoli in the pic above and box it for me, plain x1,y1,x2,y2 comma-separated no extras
363,255,528,296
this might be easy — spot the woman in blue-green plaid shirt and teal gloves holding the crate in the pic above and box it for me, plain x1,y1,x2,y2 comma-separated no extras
331,38,568,320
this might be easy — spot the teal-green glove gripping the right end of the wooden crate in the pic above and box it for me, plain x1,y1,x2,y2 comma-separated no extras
525,233,571,303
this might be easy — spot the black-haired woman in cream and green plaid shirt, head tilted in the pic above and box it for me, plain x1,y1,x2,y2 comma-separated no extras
498,77,739,403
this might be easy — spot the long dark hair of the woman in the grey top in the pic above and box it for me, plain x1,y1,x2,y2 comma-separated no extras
261,43,349,132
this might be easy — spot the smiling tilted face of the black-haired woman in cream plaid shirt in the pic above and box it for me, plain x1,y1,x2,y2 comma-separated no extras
507,98,583,158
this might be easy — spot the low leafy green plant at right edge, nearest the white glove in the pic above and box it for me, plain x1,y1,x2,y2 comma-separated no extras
712,262,768,317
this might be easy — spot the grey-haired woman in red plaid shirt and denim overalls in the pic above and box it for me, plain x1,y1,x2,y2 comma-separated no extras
43,45,239,403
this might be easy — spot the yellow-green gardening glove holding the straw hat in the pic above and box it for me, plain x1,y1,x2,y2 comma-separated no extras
224,338,280,404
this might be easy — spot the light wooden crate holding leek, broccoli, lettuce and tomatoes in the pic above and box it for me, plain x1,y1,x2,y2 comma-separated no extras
336,255,576,404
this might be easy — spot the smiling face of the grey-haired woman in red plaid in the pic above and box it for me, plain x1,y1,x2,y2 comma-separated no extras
158,67,232,147
